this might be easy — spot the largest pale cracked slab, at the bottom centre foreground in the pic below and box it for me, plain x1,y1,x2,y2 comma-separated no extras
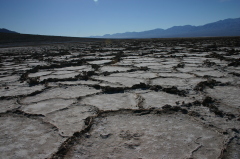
66,114,225,159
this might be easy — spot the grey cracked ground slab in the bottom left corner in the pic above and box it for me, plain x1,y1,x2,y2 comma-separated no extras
0,115,65,159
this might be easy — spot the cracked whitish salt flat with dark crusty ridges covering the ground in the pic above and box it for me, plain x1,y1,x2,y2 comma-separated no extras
0,37,240,159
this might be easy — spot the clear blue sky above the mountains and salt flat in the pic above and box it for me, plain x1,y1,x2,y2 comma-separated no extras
0,0,240,37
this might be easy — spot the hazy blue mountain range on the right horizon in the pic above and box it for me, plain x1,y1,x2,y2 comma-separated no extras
91,18,240,39
